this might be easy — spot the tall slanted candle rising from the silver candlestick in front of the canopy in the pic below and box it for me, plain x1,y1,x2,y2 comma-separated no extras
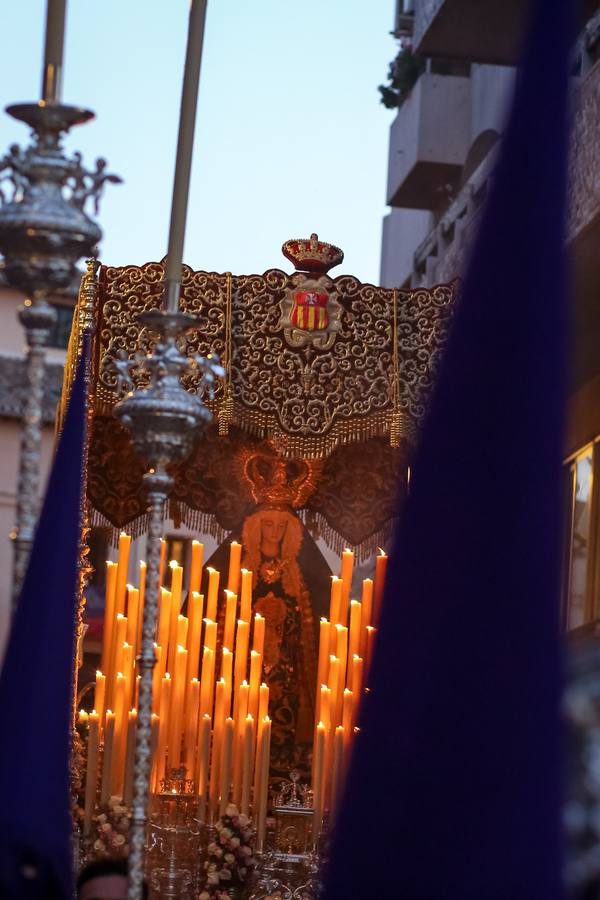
165,0,211,312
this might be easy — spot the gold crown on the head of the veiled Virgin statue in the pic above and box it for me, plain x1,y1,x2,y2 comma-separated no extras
238,441,323,509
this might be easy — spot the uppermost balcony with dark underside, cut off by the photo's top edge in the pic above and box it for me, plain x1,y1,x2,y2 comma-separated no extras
414,0,598,65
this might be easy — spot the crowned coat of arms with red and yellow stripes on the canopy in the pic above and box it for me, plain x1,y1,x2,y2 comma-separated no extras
280,234,344,350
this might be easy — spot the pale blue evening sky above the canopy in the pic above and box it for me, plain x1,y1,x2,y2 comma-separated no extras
0,0,396,282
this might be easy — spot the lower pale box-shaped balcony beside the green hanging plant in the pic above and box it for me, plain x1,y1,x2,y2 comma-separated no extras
387,72,471,210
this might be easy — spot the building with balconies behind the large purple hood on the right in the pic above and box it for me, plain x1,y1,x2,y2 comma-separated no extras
381,0,600,631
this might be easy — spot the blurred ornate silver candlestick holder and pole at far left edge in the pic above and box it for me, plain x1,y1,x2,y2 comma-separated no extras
0,101,121,604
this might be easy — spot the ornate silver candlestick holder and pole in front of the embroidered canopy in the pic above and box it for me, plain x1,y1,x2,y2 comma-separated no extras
113,310,225,900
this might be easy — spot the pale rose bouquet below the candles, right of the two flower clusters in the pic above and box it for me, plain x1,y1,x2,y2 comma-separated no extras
199,803,255,900
